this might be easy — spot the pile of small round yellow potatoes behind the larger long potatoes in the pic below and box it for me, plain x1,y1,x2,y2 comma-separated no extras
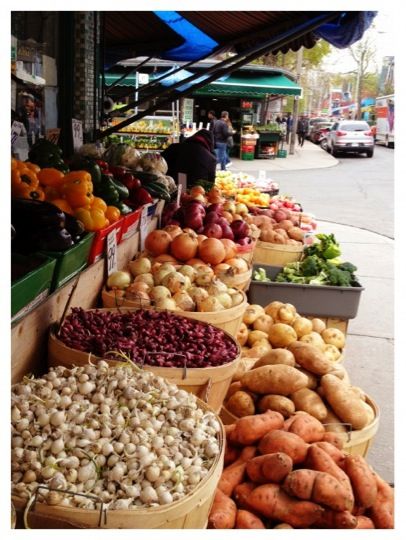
237,301,345,362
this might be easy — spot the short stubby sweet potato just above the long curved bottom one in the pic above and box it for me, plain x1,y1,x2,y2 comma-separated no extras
246,452,293,484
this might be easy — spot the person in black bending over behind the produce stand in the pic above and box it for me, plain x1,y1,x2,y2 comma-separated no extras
161,129,216,187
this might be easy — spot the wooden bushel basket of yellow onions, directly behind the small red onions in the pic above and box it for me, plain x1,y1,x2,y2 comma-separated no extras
102,292,247,338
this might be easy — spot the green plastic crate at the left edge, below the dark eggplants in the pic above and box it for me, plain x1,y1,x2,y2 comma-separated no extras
11,253,56,321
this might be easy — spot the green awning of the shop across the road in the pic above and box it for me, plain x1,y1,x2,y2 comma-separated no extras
194,75,302,99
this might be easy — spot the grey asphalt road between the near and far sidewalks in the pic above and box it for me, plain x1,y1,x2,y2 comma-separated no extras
258,145,394,238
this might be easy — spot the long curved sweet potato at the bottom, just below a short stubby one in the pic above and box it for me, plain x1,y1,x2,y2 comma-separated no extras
247,484,324,528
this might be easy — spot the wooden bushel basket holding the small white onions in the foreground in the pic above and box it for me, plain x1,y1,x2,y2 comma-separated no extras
12,400,225,529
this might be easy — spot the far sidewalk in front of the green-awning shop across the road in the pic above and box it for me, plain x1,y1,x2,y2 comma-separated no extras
229,141,338,172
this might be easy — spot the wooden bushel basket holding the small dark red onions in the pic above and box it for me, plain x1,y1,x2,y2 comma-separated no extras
48,308,241,412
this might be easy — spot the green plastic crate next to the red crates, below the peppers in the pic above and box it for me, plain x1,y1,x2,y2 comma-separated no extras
41,233,94,292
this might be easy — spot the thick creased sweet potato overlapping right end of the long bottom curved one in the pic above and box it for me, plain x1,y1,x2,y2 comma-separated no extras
282,469,354,512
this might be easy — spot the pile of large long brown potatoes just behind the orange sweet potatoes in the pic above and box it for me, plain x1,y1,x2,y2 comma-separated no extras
223,322,375,436
